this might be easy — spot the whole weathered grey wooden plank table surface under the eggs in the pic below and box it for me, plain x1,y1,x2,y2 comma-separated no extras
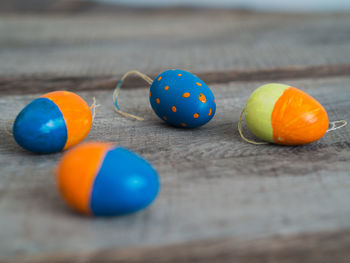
0,9,350,263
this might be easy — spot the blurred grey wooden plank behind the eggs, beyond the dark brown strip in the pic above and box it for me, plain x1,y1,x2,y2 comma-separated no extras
0,10,350,77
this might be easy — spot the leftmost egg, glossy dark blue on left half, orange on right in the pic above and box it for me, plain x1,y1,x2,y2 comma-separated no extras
13,91,92,153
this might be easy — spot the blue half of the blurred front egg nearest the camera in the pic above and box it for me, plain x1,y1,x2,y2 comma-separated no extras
90,147,159,216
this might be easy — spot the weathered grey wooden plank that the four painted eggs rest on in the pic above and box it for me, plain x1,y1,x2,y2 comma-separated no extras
0,77,350,262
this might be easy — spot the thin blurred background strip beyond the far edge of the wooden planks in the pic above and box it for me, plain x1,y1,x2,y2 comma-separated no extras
0,0,350,12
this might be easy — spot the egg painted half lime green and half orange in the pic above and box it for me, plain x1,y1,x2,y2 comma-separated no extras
245,83,328,145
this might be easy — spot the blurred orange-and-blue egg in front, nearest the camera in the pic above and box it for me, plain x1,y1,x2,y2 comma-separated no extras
56,142,159,216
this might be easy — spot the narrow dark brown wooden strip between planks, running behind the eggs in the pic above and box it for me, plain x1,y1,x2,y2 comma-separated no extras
0,64,350,96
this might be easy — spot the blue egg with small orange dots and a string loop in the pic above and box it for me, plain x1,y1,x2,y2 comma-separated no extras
149,70,216,128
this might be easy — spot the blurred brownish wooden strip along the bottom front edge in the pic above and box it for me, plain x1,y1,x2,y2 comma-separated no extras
3,231,350,263
